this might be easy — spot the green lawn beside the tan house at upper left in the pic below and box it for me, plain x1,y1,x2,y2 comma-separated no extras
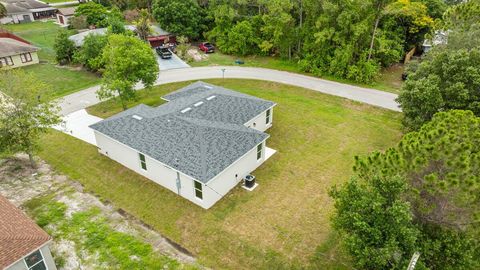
1,21,100,99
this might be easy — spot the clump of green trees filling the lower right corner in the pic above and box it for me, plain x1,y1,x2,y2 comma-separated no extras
332,110,480,269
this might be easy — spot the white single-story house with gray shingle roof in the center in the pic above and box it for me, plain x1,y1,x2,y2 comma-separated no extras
90,82,276,209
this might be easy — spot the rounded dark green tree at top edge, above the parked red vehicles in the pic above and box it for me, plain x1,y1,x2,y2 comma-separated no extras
153,0,203,38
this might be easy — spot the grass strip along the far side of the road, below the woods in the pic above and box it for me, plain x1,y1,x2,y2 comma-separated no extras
189,51,403,93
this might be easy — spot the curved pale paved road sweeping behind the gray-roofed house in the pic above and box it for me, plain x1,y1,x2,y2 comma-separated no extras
60,66,401,115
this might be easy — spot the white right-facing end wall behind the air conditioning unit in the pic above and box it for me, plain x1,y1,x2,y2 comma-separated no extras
203,141,266,209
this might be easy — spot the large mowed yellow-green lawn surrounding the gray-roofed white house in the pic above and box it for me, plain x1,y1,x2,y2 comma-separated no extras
39,79,401,269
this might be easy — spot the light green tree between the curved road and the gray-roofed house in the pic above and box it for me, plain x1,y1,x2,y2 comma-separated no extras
97,34,158,109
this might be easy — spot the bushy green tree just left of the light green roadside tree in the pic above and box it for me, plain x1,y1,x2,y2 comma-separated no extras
74,34,107,71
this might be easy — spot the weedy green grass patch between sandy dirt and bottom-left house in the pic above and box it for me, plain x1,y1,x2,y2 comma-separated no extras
27,198,188,269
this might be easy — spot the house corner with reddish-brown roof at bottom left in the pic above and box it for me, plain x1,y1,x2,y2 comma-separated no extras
0,195,57,270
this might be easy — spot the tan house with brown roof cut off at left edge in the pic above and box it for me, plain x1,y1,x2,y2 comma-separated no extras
0,30,38,69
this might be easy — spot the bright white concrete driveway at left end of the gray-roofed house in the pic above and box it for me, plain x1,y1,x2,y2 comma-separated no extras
53,109,103,145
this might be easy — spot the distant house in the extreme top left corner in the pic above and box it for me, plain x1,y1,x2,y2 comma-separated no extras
0,0,57,24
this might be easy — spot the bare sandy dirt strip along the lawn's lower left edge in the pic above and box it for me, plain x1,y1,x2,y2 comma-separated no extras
0,155,196,269
